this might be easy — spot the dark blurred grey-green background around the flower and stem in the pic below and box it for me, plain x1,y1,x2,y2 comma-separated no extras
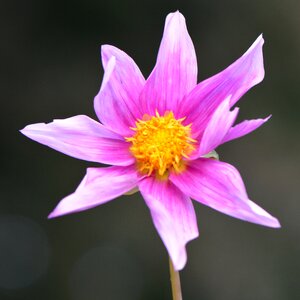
0,0,300,300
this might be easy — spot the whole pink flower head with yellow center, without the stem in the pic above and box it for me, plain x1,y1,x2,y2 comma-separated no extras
21,11,280,270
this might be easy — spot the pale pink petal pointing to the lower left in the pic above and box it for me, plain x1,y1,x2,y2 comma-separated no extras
48,166,139,218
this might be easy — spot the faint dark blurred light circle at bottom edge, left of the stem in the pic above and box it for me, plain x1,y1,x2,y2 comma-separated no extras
70,246,143,300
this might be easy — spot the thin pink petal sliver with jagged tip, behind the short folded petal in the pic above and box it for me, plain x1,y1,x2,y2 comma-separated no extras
222,116,271,143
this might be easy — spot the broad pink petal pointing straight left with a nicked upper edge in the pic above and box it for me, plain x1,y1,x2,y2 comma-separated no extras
21,115,134,166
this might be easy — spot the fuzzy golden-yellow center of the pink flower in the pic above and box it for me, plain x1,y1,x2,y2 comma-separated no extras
126,112,196,178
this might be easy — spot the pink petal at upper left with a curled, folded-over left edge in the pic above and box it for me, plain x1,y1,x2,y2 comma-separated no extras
94,45,145,136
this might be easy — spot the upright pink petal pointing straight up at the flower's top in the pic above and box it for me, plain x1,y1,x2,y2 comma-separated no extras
140,11,197,115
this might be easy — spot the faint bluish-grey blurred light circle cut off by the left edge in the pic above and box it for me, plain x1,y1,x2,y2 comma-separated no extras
0,215,50,289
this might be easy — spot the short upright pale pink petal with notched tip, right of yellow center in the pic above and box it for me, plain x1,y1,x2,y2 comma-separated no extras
197,97,238,157
